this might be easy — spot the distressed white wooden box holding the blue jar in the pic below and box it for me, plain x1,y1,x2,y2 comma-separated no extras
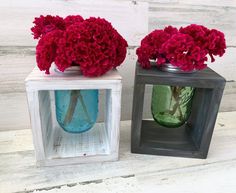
25,68,121,166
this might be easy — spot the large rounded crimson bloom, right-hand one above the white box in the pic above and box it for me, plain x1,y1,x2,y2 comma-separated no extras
76,17,127,76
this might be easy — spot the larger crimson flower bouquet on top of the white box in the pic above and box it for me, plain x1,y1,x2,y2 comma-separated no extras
31,15,128,76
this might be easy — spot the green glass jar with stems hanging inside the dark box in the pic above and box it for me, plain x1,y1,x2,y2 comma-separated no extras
151,85,194,128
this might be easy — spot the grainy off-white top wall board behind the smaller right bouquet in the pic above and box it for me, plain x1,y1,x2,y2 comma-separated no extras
149,1,236,46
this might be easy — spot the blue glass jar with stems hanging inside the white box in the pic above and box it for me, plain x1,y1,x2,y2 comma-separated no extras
55,90,98,133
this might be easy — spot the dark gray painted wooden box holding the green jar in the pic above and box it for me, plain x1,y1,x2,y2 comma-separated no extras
131,63,226,158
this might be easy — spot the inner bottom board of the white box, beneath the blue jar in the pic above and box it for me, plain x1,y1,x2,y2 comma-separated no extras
46,123,110,159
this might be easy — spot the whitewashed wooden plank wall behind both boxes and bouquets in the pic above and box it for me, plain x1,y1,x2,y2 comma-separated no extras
0,0,236,130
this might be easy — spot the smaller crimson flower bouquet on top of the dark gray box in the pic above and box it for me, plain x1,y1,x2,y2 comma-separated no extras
136,24,226,71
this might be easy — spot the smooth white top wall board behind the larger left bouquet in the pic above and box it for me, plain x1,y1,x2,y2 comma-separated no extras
0,0,148,46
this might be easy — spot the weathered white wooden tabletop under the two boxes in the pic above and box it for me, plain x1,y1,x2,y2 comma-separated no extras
0,112,236,193
